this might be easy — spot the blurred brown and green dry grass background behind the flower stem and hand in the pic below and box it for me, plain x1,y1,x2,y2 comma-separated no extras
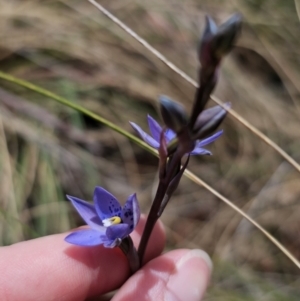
0,0,300,301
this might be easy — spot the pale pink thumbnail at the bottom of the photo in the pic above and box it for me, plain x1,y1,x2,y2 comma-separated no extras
164,250,212,301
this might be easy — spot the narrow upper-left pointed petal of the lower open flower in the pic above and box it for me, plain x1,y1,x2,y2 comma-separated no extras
67,195,103,229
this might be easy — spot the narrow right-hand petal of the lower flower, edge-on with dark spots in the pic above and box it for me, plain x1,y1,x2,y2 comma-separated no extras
121,193,141,233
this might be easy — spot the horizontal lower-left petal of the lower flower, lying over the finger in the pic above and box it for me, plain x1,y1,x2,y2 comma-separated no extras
65,227,107,247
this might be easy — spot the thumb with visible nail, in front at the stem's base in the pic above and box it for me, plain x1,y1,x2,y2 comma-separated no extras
112,249,212,301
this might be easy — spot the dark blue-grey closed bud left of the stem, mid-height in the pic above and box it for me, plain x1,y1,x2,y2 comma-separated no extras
159,95,188,133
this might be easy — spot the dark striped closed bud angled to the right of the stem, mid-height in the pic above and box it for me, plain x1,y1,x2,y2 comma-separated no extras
193,103,231,139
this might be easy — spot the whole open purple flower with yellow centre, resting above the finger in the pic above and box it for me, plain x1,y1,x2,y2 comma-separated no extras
65,187,140,248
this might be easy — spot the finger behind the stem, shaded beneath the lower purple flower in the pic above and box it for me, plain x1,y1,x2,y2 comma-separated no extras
0,217,165,301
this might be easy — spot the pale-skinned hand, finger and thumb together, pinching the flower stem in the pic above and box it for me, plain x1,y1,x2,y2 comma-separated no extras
0,217,211,301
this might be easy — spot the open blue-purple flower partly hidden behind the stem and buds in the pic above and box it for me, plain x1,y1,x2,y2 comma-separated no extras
130,115,223,155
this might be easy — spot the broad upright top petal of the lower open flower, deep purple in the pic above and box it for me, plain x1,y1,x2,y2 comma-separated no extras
94,187,122,220
